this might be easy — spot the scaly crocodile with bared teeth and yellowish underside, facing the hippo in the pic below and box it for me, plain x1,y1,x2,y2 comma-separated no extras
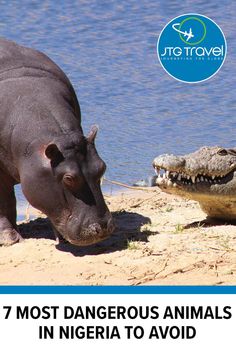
153,146,236,221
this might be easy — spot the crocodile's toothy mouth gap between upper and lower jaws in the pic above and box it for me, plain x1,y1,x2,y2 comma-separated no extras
154,166,233,187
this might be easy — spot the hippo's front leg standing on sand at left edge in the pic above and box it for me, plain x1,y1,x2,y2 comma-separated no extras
0,173,22,246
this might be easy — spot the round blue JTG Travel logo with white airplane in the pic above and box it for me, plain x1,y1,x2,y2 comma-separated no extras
157,14,227,83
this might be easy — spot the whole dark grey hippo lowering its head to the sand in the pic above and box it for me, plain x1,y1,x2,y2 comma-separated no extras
0,39,114,245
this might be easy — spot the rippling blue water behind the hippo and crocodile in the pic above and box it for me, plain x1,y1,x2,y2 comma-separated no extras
0,0,236,218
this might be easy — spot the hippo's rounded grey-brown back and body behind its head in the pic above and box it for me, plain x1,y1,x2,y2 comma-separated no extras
0,38,82,179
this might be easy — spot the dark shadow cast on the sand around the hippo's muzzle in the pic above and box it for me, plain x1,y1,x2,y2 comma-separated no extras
19,211,157,257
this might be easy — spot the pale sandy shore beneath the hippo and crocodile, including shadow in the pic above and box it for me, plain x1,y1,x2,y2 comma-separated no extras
0,188,236,285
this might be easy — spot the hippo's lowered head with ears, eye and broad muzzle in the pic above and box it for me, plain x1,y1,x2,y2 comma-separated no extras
21,126,114,246
